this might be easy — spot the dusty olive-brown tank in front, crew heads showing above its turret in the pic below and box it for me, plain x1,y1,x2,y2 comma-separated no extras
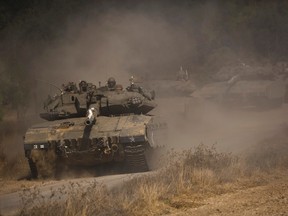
24,78,166,178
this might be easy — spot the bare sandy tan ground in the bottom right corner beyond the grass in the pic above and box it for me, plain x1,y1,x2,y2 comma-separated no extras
167,173,288,216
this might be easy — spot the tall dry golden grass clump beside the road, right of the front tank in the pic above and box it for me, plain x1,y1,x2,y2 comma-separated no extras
120,144,243,215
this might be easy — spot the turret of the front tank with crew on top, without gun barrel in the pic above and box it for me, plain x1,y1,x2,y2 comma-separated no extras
40,78,156,121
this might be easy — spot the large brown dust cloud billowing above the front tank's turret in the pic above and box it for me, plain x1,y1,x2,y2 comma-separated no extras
24,1,249,109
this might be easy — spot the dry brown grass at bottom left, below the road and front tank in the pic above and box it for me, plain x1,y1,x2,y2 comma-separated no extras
18,182,123,216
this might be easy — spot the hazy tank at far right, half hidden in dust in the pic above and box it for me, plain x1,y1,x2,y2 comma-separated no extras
191,64,285,109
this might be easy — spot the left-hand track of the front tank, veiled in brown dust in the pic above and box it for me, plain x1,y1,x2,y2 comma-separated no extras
29,149,56,178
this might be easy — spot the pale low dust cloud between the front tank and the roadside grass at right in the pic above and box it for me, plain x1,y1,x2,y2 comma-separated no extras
158,98,287,153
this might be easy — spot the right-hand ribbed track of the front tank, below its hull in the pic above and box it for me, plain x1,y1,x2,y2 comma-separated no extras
124,144,149,172
